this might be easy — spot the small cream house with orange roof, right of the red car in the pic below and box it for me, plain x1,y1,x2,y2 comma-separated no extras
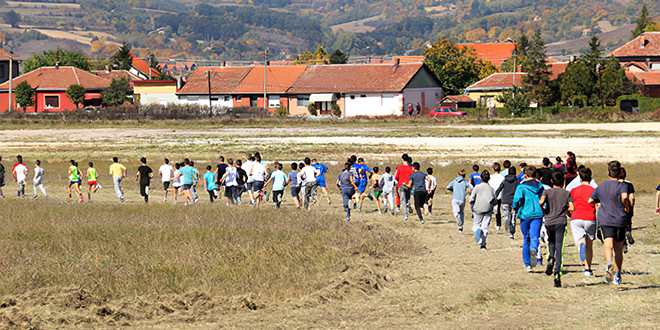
465,72,527,107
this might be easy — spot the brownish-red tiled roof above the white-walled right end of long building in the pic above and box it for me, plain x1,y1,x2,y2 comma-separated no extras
289,63,423,94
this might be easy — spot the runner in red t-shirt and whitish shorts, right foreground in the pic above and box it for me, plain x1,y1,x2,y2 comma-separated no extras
570,167,596,276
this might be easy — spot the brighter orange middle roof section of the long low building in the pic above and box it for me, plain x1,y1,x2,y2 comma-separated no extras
234,65,307,93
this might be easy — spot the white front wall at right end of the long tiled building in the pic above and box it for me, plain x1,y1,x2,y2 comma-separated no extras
344,93,403,118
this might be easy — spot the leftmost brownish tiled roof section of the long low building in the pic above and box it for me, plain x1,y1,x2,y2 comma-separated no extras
179,66,251,94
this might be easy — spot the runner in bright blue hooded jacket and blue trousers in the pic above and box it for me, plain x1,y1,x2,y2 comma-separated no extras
513,165,543,272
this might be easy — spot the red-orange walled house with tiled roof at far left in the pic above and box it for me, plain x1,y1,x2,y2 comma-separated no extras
0,66,111,112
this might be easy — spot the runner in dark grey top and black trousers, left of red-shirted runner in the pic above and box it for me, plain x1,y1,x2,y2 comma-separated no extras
539,169,573,288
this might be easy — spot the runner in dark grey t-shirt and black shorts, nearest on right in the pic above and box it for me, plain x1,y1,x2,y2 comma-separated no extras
589,161,629,285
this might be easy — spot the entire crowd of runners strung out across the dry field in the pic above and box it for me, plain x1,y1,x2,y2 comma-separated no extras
0,151,640,287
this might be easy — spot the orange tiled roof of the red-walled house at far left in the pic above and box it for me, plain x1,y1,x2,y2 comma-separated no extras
0,66,112,90
